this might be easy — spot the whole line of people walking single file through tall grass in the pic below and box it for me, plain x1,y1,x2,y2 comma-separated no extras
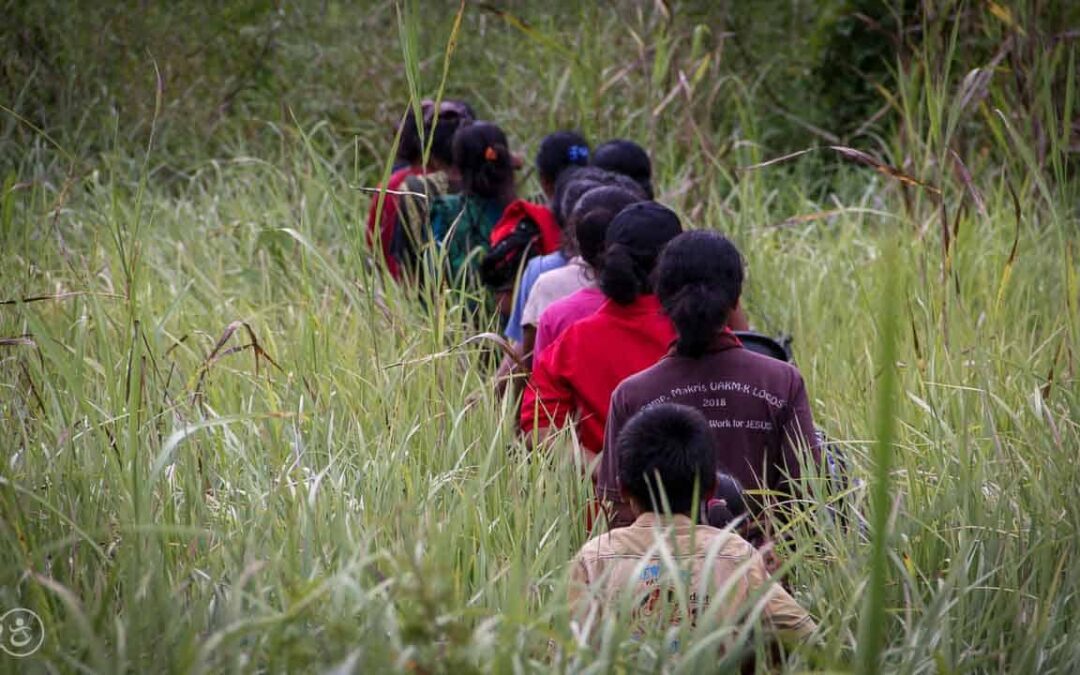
368,100,821,637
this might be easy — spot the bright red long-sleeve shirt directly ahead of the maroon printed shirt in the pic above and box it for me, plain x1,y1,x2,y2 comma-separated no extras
521,295,675,453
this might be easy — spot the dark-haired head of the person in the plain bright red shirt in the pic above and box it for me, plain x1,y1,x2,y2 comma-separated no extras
600,202,683,305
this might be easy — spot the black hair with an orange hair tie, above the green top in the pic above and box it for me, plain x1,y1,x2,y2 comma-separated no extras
454,122,514,199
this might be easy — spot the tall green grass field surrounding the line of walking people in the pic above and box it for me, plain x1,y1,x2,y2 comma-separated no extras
0,0,1080,674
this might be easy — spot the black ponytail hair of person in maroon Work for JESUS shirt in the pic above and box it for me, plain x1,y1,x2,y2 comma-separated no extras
657,231,744,357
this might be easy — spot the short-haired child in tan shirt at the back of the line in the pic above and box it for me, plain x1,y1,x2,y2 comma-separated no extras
569,404,815,640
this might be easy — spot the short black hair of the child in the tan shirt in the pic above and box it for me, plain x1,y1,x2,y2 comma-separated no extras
615,403,716,515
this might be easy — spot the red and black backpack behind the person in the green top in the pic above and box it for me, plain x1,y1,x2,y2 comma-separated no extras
480,199,563,289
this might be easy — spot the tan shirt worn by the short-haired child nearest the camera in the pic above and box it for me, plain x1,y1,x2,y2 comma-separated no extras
569,513,816,639
